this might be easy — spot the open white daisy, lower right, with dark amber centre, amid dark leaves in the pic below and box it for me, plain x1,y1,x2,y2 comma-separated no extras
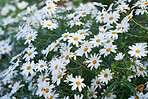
98,69,114,84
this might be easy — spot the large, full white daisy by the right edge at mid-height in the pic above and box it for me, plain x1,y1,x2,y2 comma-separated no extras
128,43,148,58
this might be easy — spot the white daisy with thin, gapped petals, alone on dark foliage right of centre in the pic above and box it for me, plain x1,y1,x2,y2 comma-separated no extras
85,54,102,70
